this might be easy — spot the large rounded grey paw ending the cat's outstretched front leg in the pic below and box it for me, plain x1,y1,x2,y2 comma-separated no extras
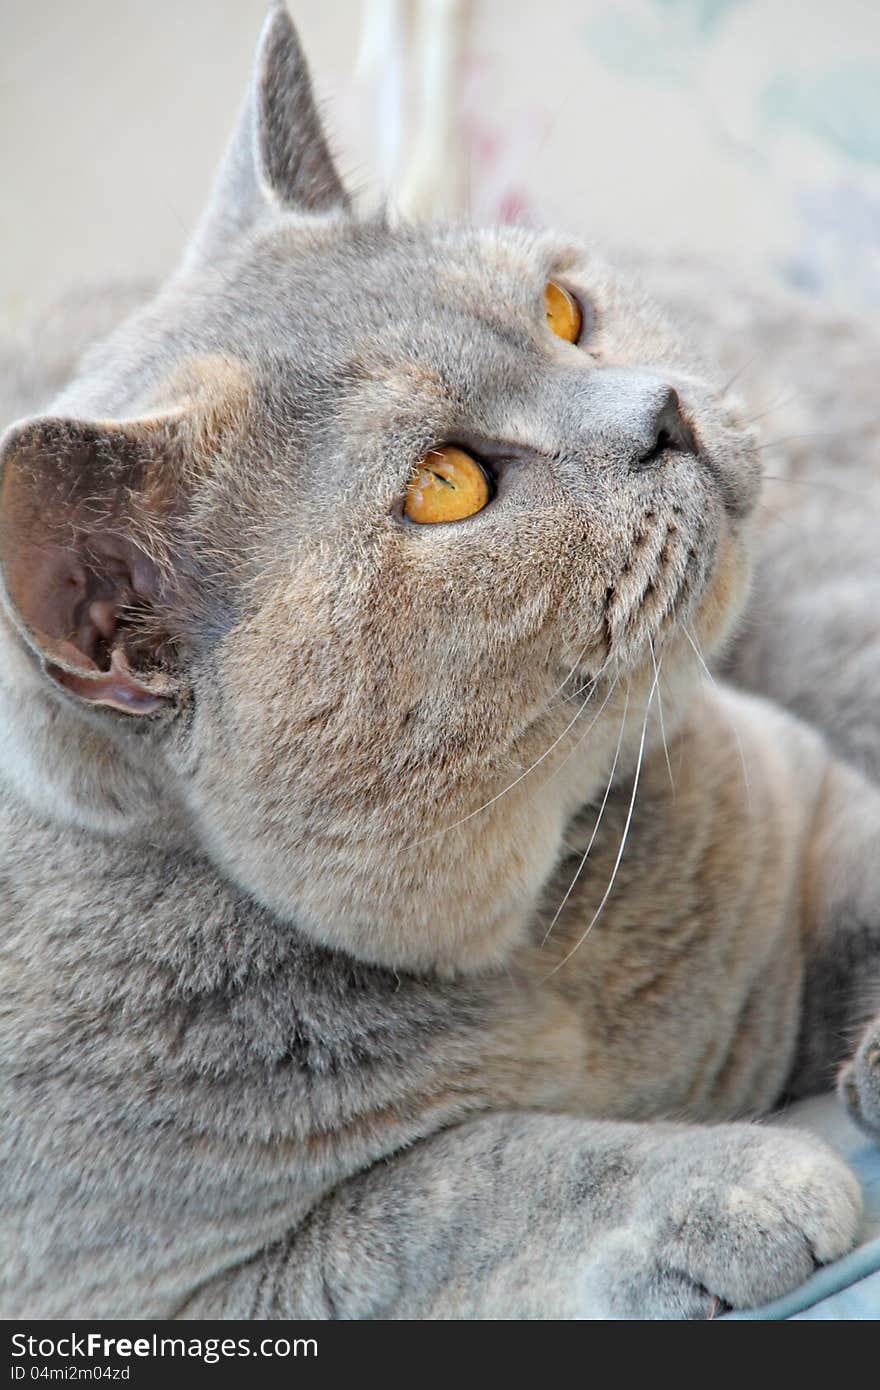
588,1125,862,1318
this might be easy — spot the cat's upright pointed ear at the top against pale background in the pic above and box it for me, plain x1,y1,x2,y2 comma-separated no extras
185,3,350,265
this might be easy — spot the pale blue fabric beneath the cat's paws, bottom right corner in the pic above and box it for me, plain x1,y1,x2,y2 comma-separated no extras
727,1095,880,1321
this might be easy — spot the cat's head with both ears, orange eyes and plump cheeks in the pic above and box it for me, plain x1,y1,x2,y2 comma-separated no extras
0,7,758,970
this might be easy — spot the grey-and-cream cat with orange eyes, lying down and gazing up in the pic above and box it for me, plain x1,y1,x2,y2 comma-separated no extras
0,4,880,1318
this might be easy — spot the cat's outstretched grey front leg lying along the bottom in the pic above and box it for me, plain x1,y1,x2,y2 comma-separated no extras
179,1115,861,1319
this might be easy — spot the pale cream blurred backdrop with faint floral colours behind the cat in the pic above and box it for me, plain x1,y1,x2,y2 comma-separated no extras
0,0,880,318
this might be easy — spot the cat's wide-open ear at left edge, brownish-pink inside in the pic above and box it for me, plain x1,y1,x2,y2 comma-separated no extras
0,413,178,714
